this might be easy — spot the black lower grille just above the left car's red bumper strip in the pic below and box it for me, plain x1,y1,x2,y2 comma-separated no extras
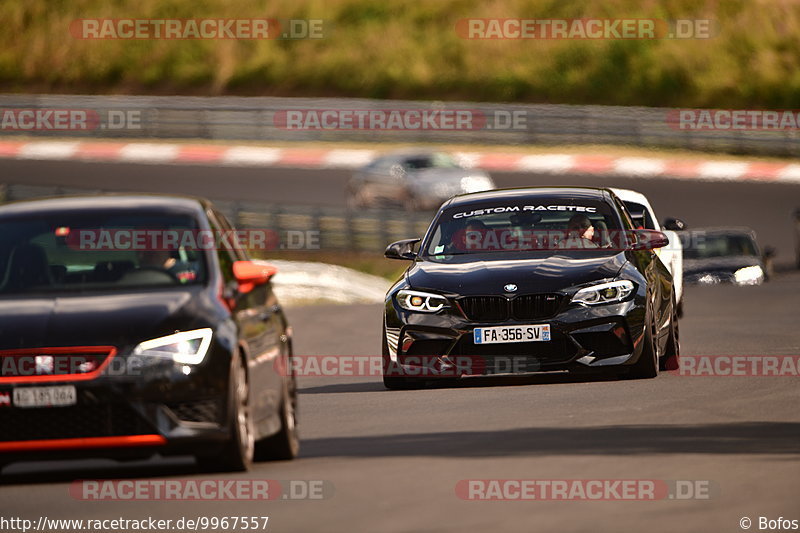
0,393,156,442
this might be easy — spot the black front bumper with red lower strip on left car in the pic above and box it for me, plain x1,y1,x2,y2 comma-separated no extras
0,344,230,463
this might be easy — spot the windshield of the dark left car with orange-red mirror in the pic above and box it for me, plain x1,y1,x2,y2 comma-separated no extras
0,211,206,295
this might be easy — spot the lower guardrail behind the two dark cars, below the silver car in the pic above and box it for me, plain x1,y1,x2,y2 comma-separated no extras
0,183,432,253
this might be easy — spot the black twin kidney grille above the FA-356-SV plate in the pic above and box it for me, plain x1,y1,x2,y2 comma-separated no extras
458,294,563,322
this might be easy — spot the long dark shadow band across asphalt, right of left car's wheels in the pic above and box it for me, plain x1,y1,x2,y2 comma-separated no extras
303,422,800,459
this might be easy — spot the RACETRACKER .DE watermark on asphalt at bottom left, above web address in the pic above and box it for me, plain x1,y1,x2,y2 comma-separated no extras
69,478,334,501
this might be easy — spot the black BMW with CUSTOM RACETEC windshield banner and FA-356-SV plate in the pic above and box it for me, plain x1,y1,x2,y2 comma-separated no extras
383,188,679,389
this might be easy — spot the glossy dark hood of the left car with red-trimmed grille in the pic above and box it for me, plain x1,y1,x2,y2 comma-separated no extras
0,287,208,350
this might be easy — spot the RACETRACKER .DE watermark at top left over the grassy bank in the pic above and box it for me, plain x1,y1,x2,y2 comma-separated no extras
69,18,325,40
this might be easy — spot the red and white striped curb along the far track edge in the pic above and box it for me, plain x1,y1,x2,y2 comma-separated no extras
0,141,800,184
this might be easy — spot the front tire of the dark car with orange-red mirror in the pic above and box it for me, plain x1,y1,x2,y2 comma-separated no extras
197,354,255,472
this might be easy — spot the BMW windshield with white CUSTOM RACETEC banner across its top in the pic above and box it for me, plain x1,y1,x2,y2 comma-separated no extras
423,198,625,256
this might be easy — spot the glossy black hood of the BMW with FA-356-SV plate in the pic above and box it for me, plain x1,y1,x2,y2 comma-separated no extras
406,251,627,295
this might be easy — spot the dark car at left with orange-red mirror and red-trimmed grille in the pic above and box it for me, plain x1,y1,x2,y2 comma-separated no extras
0,196,298,470
